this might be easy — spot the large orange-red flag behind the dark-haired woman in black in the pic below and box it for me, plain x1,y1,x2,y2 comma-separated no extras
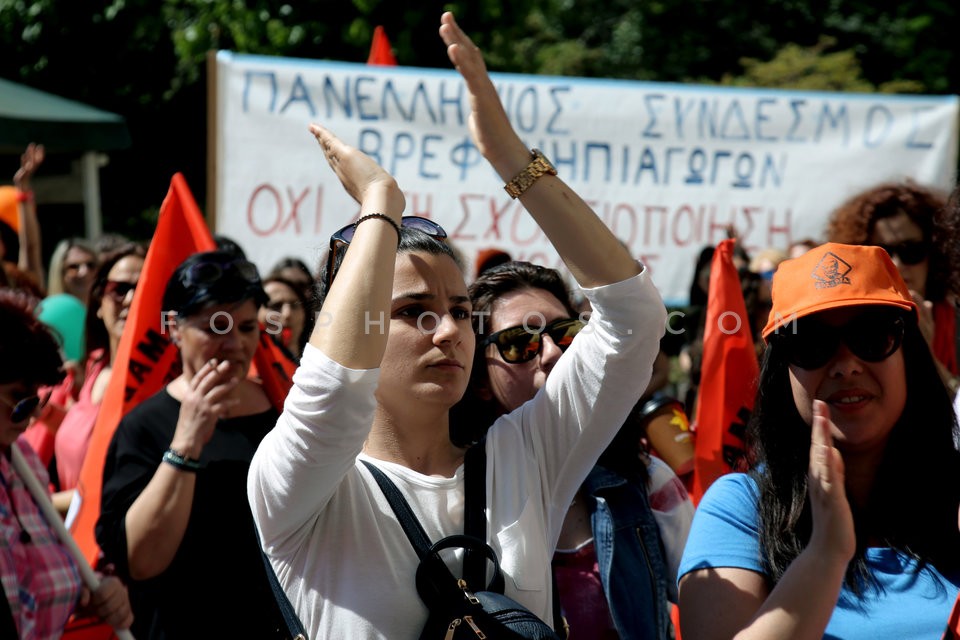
70,173,293,566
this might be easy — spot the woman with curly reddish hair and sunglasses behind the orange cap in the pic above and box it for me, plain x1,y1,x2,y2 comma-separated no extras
827,182,960,382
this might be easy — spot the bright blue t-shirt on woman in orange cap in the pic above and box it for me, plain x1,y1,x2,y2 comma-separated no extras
678,473,960,640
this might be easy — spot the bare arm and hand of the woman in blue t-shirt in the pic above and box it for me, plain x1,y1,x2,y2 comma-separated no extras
680,400,856,640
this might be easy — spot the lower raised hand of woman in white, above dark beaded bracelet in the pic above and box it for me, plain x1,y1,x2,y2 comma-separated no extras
310,124,406,214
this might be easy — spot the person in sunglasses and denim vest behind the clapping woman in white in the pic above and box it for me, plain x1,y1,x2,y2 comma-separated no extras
451,262,693,640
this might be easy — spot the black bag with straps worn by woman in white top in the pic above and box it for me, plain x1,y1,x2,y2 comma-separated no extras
363,441,559,640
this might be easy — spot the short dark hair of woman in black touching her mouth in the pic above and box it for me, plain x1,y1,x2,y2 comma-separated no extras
163,250,268,317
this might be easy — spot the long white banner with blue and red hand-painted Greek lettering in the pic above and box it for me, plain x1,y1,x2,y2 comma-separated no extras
214,51,958,304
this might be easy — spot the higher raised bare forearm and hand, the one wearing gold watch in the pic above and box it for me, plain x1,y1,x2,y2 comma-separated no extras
440,12,640,287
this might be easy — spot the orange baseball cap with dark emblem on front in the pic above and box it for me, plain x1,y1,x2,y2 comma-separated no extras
762,242,917,340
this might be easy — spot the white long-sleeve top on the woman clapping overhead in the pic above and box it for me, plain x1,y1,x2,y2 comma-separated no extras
248,271,666,640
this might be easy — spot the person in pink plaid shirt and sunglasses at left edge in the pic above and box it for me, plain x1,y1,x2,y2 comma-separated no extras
0,289,132,640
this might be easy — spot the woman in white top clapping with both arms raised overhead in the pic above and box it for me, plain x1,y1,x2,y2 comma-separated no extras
248,13,665,639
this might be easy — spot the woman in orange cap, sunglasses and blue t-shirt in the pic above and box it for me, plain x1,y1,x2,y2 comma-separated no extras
680,243,960,640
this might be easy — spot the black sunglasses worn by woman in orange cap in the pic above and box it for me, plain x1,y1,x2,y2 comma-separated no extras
771,312,905,370
